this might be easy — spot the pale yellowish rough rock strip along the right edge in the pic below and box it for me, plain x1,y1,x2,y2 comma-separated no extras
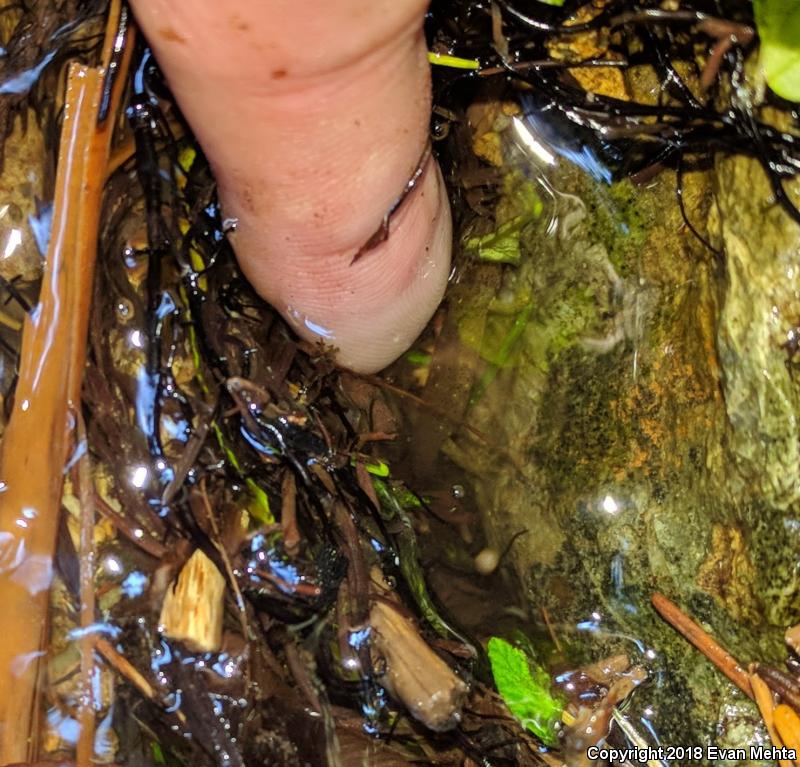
712,151,800,508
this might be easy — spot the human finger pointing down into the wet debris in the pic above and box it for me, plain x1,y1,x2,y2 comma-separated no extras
132,0,451,372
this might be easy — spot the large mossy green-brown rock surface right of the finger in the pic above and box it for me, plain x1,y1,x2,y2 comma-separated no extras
412,100,800,746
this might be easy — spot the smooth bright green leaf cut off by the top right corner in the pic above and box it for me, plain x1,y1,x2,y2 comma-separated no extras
753,0,800,101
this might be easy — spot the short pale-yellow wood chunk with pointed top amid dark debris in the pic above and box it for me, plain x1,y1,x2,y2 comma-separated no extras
159,549,225,652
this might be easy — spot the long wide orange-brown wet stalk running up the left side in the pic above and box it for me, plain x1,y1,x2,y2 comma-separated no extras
0,0,131,764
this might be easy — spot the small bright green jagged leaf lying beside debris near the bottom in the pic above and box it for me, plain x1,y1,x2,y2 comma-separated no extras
487,637,564,746
